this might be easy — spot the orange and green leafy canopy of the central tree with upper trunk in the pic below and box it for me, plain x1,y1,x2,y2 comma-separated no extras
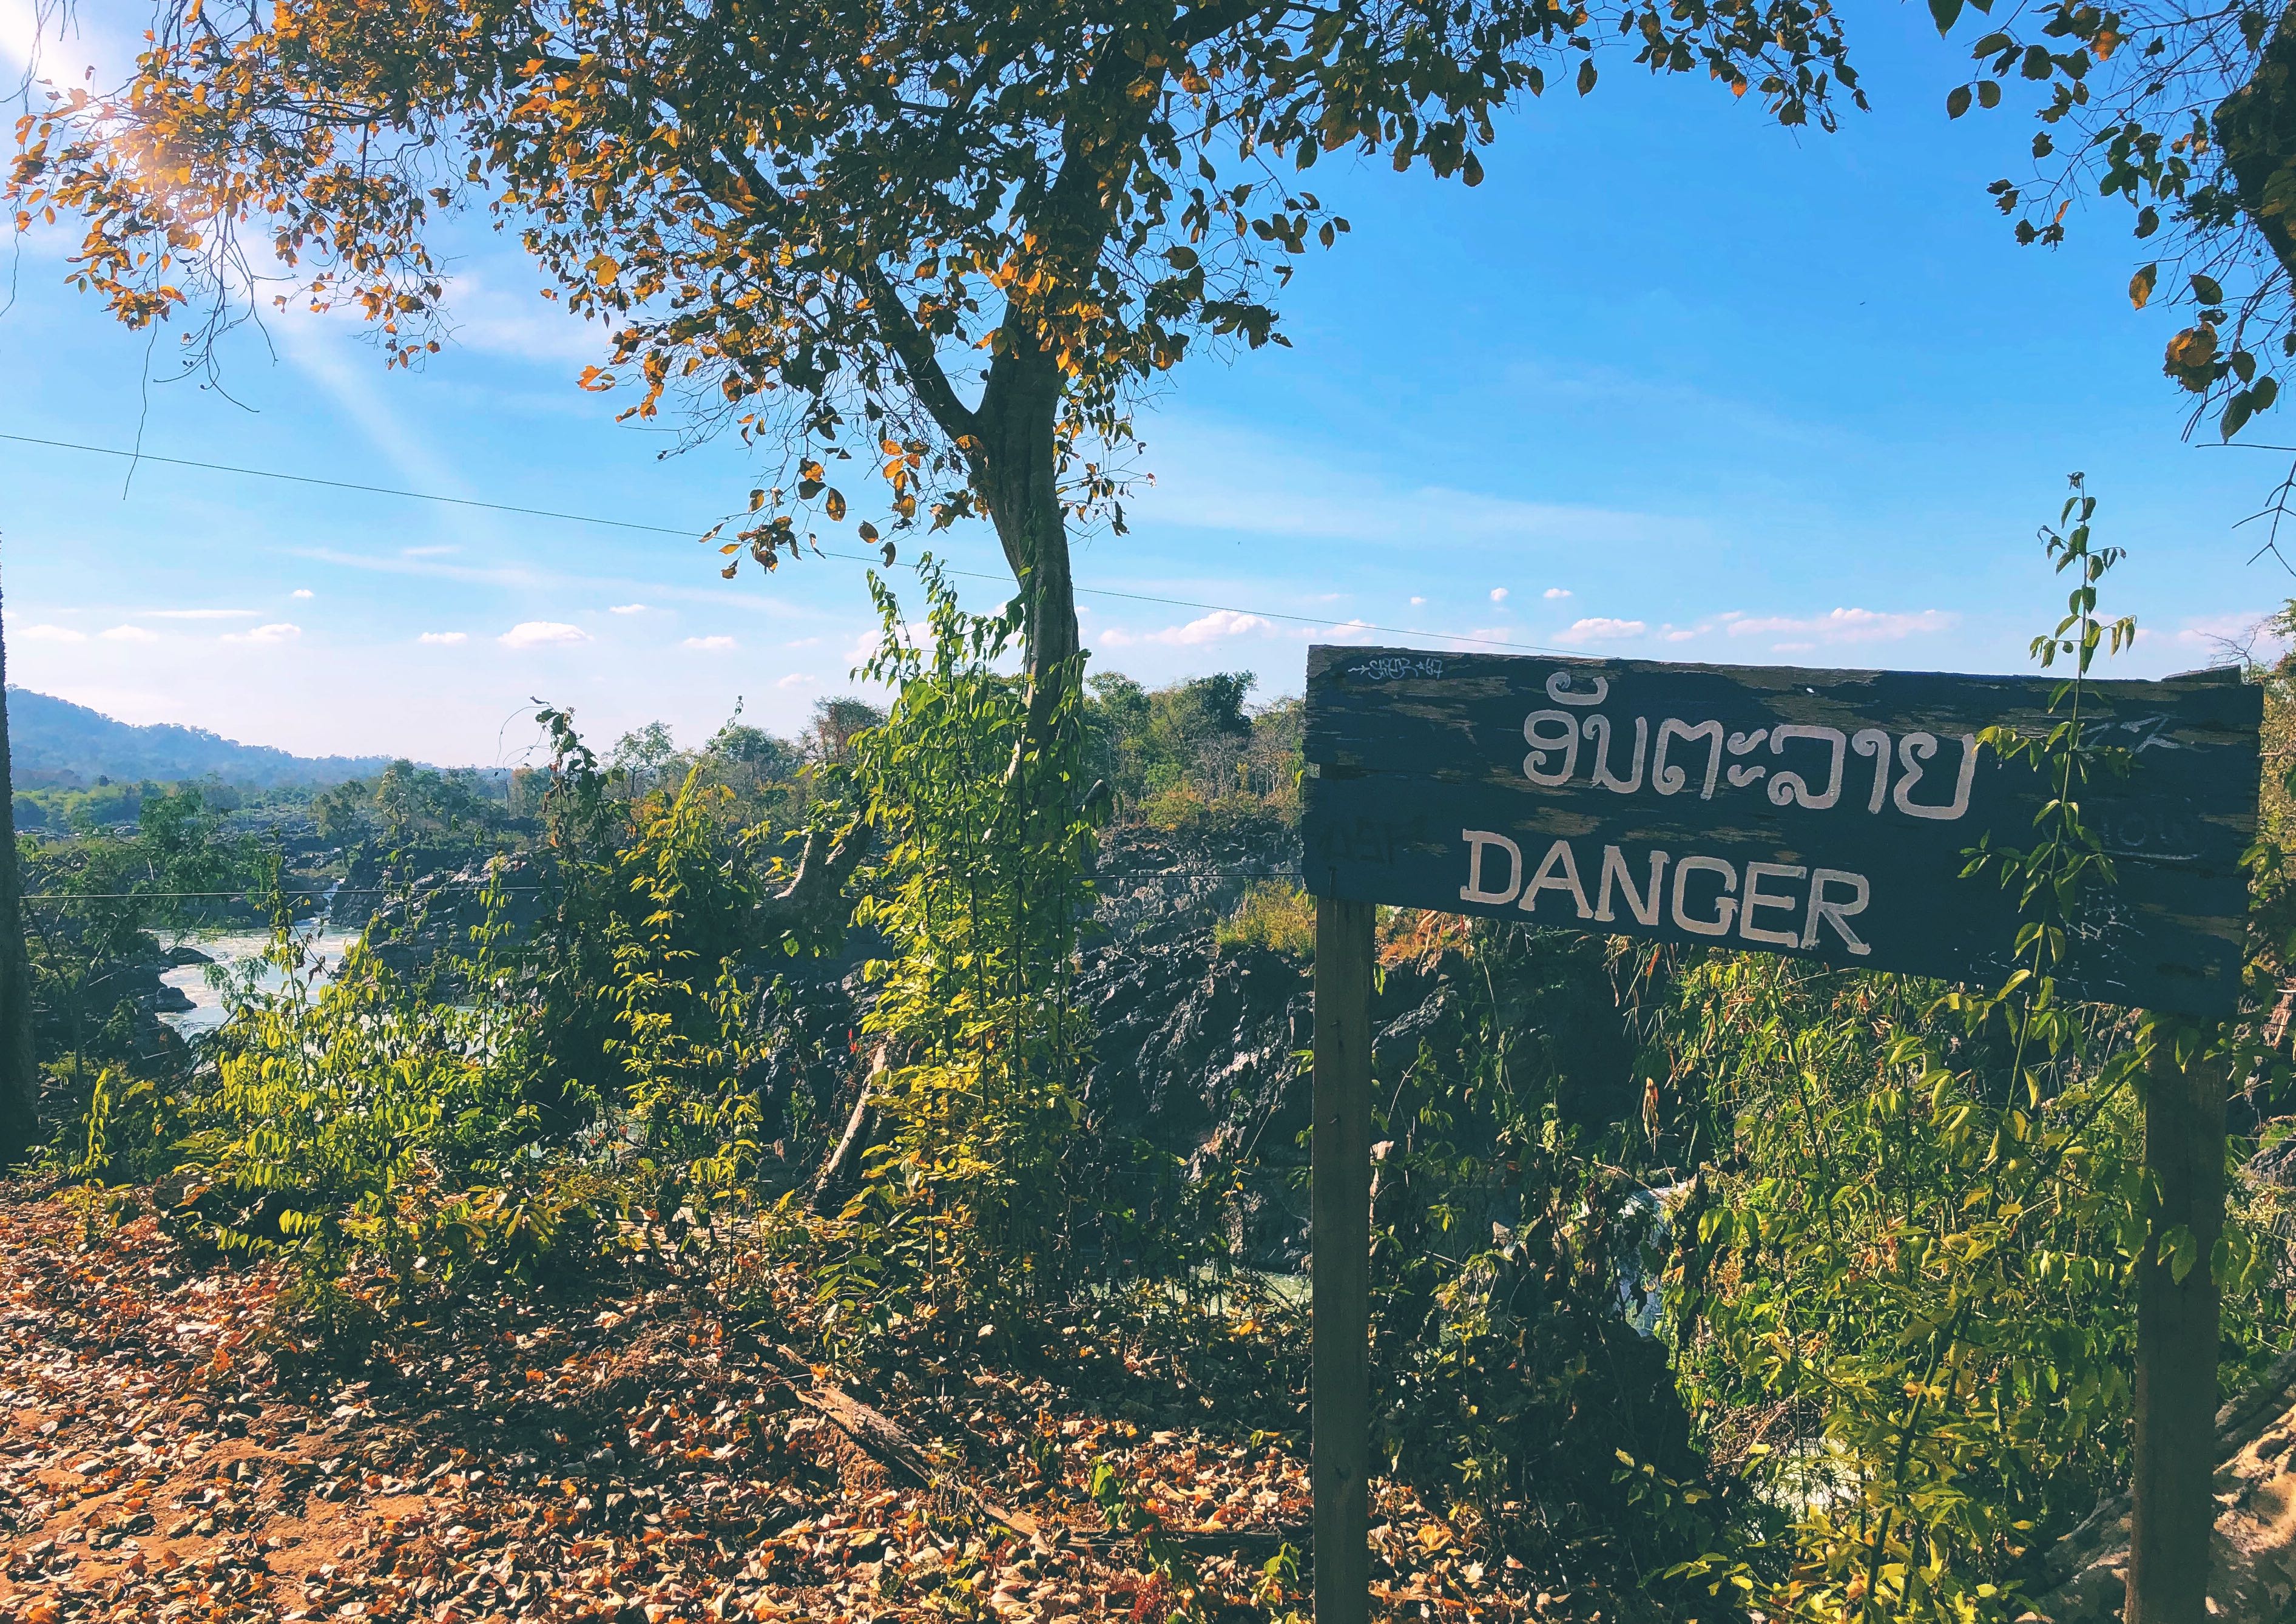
9,0,1862,753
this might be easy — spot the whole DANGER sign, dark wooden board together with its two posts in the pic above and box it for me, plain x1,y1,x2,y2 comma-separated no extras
1304,648,2264,1624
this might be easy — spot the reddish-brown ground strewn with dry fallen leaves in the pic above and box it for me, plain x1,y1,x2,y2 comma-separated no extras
0,1188,1605,1624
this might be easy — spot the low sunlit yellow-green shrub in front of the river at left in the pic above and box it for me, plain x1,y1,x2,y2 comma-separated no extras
131,868,643,1341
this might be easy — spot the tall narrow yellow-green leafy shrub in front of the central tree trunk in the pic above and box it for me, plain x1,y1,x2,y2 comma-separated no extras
820,561,1093,1350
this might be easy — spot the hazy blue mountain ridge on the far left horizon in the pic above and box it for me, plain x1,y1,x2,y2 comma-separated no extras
7,687,390,788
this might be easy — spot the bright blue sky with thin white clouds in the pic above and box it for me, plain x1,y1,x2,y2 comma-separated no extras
0,0,2296,763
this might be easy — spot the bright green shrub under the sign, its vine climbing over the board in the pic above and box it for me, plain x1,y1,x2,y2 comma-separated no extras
1644,496,2289,1622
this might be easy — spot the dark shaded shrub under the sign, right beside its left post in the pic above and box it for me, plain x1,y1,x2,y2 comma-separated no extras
1371,924,1743,1617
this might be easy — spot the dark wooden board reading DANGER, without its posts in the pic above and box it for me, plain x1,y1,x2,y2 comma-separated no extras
1304,648,2264,1015
